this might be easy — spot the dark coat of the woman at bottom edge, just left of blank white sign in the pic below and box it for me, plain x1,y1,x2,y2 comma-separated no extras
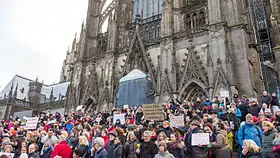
167,142,186,158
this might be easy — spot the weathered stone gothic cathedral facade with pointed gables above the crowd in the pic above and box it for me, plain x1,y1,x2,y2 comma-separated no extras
61,0,280,110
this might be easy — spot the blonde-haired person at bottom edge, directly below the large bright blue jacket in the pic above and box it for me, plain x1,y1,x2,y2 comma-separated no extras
242,139,262,158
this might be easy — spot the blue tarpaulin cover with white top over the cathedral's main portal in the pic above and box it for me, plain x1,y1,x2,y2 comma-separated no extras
117,69,155,109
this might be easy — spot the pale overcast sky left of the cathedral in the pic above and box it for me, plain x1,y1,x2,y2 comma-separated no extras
0,0,88,91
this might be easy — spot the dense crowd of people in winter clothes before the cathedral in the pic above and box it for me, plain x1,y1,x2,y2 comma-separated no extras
0,92,280,158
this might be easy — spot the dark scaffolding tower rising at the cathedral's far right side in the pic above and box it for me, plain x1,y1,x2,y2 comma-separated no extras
248,0,278,92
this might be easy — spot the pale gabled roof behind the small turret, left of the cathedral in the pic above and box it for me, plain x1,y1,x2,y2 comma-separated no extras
0,75,69,103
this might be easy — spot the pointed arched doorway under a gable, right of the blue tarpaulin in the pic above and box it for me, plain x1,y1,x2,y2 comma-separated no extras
179,80,208,102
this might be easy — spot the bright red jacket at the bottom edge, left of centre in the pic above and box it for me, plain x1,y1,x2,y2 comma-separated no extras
51,141,72,158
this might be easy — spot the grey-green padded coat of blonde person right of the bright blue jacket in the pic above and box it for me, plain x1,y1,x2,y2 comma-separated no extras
262,128,277,158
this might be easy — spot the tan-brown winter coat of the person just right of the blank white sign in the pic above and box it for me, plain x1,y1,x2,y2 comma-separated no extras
212,130,230,158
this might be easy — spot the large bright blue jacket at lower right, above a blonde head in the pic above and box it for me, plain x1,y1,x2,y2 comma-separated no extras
238,122,262,147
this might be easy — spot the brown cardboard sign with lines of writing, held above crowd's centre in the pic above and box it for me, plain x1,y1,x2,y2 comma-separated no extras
143,104,164,121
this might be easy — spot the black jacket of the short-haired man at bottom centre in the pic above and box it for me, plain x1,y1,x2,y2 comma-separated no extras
139,141,158,158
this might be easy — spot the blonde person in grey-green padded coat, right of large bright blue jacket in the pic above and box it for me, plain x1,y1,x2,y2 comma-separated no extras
262,121,277,158
